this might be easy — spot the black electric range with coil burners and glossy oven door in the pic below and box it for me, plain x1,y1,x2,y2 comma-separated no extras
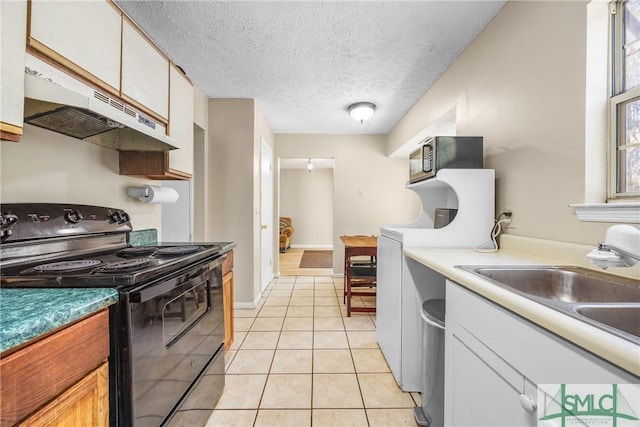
0,203,233,426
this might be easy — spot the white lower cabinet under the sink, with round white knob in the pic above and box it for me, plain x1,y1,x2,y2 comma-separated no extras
445,281,640,427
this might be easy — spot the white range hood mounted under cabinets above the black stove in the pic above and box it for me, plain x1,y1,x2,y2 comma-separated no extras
24,55,178,151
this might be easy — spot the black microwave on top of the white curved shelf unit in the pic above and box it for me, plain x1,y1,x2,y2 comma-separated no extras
409,136,484,184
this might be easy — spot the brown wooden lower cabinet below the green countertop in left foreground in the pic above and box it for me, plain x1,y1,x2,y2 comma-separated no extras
0,309,109,427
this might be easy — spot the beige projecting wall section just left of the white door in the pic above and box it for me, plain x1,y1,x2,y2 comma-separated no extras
206,99,273,305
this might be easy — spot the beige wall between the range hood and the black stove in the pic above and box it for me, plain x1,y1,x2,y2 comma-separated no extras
0,125,161,233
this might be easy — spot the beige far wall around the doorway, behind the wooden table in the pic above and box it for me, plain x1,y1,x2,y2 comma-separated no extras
275,134,420,272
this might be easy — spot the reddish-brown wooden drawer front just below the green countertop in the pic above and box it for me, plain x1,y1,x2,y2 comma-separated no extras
0,309,109,425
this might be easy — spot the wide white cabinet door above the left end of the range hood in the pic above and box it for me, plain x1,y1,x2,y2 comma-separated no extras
28,0,122,94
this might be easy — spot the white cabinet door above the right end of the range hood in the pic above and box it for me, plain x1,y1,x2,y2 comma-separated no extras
122,19,169,120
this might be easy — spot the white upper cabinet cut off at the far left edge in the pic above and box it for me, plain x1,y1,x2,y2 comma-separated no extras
0,1,27,141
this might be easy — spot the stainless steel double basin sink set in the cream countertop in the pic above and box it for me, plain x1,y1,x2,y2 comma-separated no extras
458,265,640,345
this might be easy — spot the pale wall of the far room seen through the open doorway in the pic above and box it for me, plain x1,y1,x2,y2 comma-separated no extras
280,169,333,247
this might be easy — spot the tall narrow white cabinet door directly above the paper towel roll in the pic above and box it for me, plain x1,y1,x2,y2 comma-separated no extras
169,66,193,175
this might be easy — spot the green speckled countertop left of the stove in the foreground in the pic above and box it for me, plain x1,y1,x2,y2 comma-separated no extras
0,288,118,353
